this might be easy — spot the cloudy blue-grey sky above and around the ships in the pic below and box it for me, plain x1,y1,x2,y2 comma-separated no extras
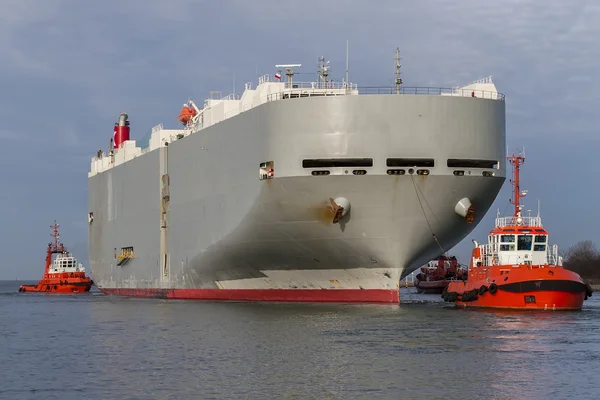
0,0,600,279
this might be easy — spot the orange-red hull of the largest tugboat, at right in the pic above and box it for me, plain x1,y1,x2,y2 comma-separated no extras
442,265,592,310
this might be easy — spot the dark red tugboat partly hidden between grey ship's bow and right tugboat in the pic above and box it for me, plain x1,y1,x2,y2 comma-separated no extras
414,255,467,294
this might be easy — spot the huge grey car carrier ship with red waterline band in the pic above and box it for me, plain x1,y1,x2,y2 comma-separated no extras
88,54,506,303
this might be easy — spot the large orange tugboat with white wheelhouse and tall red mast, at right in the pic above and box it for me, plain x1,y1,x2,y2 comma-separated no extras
442,153,592,310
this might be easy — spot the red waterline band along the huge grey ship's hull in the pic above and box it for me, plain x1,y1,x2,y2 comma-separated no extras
99,288,400,304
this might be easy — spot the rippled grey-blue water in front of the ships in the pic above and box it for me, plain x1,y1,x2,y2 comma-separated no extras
0,282,600,400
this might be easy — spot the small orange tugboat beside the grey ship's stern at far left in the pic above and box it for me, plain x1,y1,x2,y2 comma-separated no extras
19,221,93,293
